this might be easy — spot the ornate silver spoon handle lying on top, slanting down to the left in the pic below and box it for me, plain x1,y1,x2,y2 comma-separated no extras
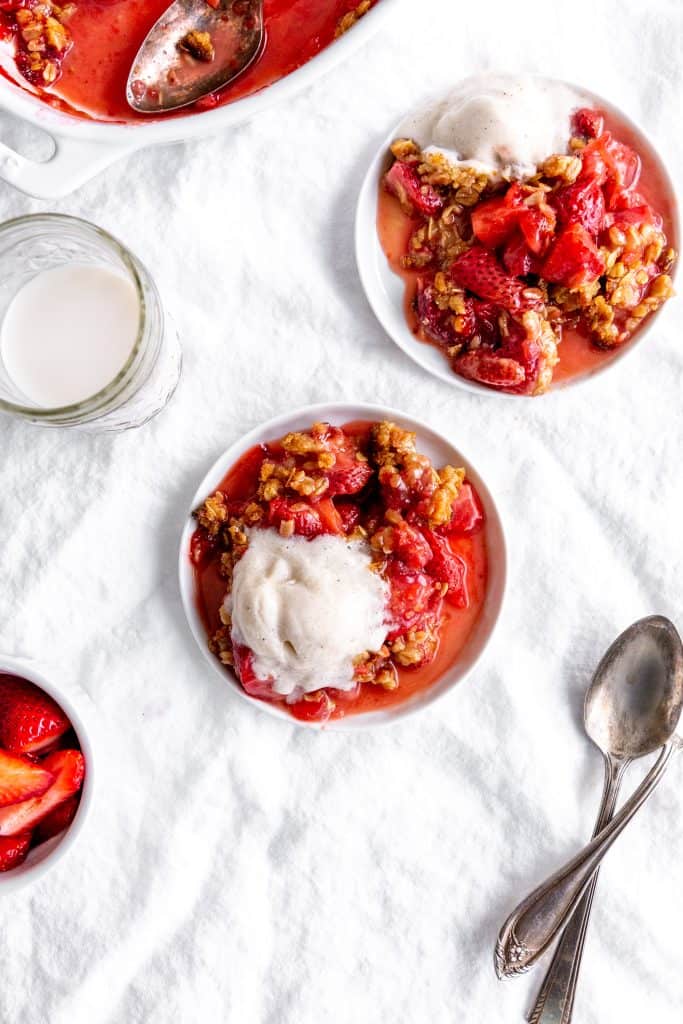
495,740,678,978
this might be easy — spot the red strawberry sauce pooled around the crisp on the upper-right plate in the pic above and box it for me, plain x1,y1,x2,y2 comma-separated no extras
377,112,679,386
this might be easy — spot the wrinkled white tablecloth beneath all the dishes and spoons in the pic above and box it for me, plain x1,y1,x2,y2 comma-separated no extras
0,0,683,1024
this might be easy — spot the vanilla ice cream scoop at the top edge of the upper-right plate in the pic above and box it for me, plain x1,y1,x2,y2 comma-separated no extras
398,75,590,179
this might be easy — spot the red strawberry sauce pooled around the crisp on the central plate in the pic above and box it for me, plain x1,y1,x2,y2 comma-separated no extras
191,421,487,718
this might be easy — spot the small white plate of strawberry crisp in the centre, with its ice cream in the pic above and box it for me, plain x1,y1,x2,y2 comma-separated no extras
179,404,506,728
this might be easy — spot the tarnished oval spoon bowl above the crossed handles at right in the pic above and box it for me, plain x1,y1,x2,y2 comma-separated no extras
584,615,683,760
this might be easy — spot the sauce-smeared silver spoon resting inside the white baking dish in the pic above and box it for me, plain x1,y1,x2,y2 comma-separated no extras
126,0,265,114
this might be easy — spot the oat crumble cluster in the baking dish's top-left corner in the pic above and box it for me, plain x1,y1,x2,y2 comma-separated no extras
1,0,76,88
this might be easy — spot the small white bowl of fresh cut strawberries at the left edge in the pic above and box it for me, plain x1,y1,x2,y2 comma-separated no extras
0,655,94,895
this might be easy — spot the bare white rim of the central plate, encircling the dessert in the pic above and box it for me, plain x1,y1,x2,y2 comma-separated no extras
178,403,507,730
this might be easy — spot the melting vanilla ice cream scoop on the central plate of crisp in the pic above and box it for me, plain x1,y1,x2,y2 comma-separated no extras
224,529,389,698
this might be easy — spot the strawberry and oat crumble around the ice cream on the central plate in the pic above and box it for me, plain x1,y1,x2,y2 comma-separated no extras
193,422,483,718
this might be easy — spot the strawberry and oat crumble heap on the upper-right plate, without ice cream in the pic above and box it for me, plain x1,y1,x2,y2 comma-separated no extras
384,110,676,394
